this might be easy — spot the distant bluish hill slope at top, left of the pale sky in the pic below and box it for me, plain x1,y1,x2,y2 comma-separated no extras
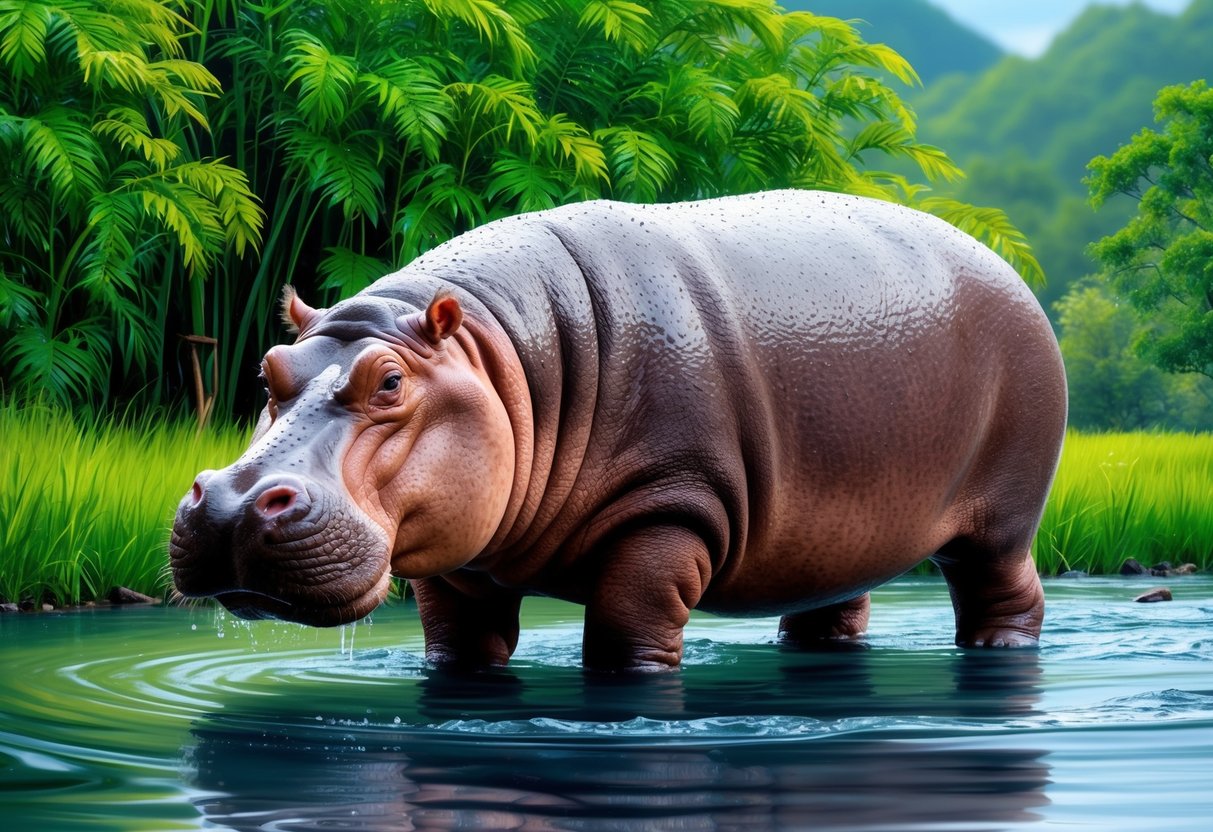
780,0,1003,85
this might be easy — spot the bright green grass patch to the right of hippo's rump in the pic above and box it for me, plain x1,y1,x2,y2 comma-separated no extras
1033,432,1213,574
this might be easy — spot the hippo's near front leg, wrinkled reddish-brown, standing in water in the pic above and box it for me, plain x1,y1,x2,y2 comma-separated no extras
581,526,711,671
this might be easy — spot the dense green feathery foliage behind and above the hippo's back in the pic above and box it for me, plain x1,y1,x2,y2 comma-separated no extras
0,0,1038,414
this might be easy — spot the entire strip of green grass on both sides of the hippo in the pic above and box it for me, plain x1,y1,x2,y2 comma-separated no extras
0,404,1213,604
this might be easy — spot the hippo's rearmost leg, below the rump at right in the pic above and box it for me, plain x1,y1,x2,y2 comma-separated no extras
934,540,1044,648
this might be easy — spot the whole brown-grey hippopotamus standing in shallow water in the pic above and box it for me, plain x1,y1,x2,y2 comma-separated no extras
170,190,1066,671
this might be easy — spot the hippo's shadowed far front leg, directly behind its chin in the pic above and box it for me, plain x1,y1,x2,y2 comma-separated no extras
409,577,523,667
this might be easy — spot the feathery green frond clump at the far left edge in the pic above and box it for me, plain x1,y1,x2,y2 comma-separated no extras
0,0,261,403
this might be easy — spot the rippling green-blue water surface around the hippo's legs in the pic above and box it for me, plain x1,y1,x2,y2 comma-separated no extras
0,576,1213,831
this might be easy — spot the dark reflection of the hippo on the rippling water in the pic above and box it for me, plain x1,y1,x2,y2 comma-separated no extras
187,645,1049,830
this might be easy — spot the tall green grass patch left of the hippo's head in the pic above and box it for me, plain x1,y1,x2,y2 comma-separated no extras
0,404,247,604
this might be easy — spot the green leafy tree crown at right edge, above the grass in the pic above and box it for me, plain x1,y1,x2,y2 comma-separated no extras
1088,81,1213,385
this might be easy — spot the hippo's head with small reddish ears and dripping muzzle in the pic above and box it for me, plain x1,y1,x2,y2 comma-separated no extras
170,290,514,626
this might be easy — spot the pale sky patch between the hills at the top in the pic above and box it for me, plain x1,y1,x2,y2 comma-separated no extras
930,0,1188,58
